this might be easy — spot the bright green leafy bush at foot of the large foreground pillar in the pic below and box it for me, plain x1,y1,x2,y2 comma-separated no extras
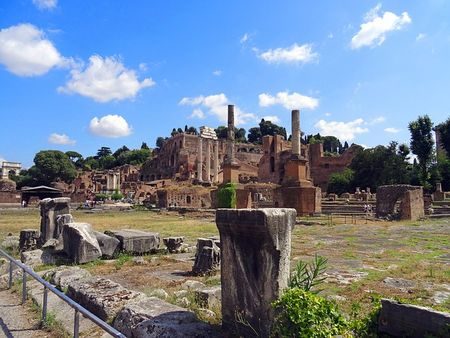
272,288,349,338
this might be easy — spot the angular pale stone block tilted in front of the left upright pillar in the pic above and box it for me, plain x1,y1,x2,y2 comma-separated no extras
63,223,102,264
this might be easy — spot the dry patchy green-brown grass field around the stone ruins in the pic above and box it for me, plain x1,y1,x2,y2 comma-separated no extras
0,209,450,315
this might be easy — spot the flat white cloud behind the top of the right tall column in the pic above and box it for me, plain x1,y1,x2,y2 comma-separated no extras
258,91,319,109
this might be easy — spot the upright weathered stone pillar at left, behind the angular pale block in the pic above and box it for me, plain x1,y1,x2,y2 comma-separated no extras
39,197,70,244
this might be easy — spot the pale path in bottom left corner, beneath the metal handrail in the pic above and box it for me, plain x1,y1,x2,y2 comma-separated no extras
0,290,51,338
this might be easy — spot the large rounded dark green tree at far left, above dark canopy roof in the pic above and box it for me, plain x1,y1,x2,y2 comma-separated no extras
30,150,77,184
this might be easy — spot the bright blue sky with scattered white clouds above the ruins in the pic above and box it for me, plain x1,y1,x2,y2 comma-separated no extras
0,0,450,166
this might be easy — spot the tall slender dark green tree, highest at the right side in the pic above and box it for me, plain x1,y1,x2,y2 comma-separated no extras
408,115,434,185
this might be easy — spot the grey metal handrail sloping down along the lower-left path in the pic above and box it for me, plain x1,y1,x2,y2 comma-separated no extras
0,249,126,338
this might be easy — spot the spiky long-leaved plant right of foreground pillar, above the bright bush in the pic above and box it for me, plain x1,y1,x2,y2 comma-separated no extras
288,255,328,293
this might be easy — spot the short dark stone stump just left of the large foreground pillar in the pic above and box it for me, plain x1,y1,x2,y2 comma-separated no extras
192,238,220,275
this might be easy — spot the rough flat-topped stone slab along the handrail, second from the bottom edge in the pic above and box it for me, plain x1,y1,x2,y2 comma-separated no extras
67,277,145,321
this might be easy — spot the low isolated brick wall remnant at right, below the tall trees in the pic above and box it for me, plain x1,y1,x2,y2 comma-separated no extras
377,184,424,220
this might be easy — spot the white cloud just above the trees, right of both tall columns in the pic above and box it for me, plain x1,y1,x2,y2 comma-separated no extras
314,118,369,141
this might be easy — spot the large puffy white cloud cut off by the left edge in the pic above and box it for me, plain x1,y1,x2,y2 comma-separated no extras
0,23,71,76
